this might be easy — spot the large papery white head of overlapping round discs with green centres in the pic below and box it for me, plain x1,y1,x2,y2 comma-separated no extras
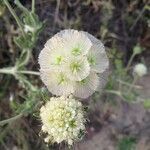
39,29,109,98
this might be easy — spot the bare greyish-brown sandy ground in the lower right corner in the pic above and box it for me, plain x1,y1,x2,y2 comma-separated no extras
76,76,150,150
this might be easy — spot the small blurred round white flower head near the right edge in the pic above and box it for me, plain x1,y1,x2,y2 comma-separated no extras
133,63,147,77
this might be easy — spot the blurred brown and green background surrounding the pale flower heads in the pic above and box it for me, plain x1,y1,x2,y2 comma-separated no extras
0,0,150,150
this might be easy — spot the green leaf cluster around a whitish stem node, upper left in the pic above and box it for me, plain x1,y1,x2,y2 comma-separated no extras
14,0,45,49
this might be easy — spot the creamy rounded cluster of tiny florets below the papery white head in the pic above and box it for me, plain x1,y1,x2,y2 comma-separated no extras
40,96,86,145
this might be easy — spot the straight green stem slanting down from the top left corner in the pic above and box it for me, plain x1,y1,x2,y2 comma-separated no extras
4,0,25,36
